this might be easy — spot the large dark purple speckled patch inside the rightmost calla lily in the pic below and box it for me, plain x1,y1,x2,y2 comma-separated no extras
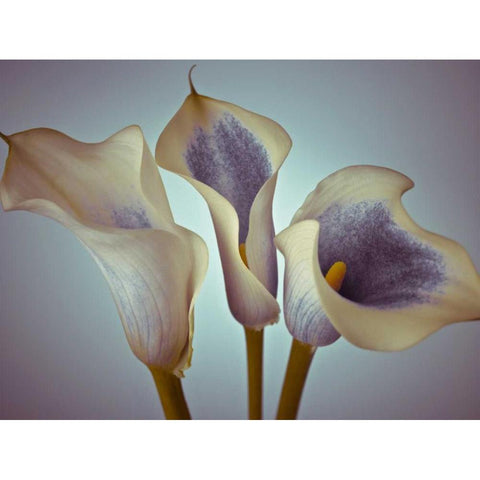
318,201,446,308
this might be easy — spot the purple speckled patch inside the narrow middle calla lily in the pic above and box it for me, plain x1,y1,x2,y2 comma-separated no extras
184,113,272,243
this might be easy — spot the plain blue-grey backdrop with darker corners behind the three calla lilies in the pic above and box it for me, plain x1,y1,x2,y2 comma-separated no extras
0,61,480,419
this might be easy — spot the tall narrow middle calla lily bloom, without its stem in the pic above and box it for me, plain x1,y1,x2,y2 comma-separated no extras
155,77,291,329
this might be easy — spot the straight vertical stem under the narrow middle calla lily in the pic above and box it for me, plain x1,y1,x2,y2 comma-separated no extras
245,327,263,420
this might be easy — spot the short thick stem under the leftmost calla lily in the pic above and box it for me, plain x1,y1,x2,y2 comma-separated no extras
148,367,191,420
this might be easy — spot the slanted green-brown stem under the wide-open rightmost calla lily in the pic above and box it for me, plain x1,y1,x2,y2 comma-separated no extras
277,338,317,420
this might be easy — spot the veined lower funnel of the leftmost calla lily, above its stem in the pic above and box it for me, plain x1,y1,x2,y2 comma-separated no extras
82,227,208,376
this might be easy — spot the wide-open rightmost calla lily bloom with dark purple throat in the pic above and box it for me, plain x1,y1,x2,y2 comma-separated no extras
275,166,480,351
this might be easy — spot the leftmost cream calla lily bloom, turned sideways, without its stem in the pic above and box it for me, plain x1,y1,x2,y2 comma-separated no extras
0,126,208,376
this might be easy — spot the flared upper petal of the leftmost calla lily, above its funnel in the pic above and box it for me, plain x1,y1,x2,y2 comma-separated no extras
2,126,173,229
